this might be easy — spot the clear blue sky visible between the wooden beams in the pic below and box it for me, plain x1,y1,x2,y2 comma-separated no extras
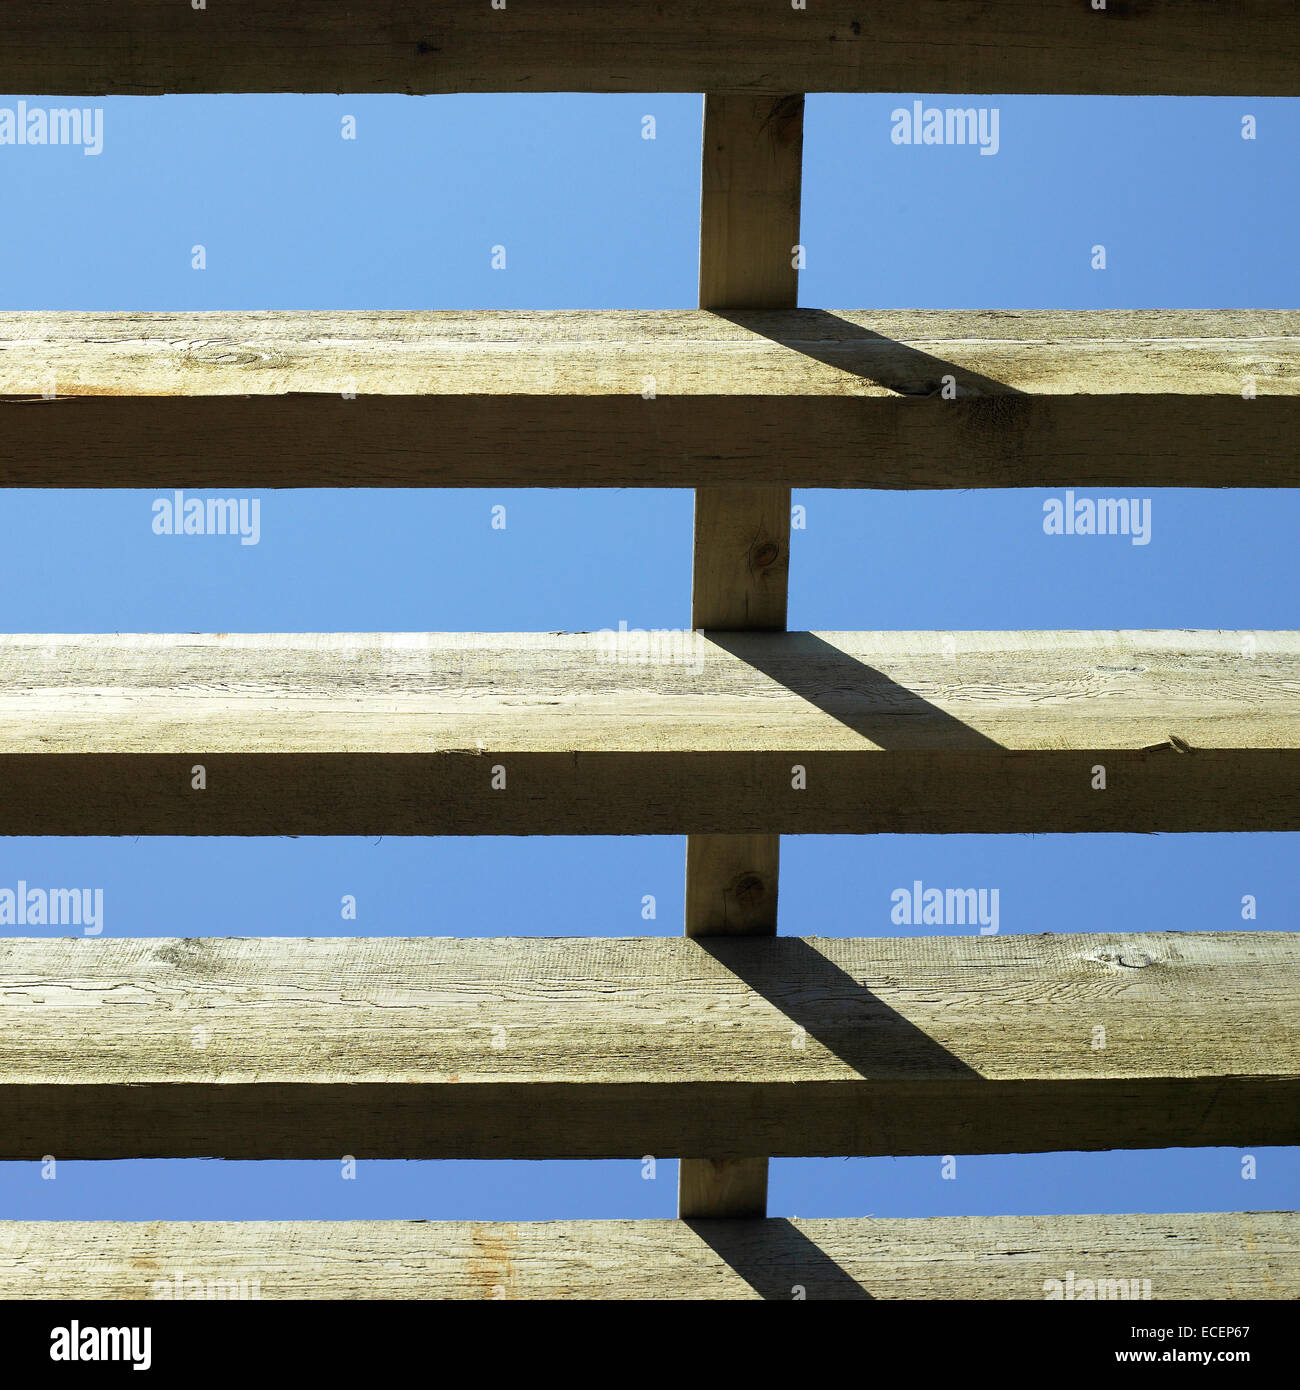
0,93,1300,1220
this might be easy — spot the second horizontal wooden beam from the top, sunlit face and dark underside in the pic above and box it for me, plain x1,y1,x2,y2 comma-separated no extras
0,309,1300,489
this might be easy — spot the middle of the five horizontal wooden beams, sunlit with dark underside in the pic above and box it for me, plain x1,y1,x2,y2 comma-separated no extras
0,633,1300,835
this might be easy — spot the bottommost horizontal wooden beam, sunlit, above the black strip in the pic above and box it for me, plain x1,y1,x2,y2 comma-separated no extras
0,1212,1300,1302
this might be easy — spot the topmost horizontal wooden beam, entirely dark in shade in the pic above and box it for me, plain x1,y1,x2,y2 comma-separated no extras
0,0,1300,96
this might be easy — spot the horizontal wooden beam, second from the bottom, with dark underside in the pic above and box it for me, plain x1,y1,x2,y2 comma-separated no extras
0,934,1300,1159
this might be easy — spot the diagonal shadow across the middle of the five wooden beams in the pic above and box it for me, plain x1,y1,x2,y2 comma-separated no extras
704,630,1002,751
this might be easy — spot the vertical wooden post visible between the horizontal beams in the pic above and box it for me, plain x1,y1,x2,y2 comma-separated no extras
677,95,804,1218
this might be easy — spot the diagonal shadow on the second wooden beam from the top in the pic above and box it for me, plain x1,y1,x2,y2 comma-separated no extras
710,309,1027,400
